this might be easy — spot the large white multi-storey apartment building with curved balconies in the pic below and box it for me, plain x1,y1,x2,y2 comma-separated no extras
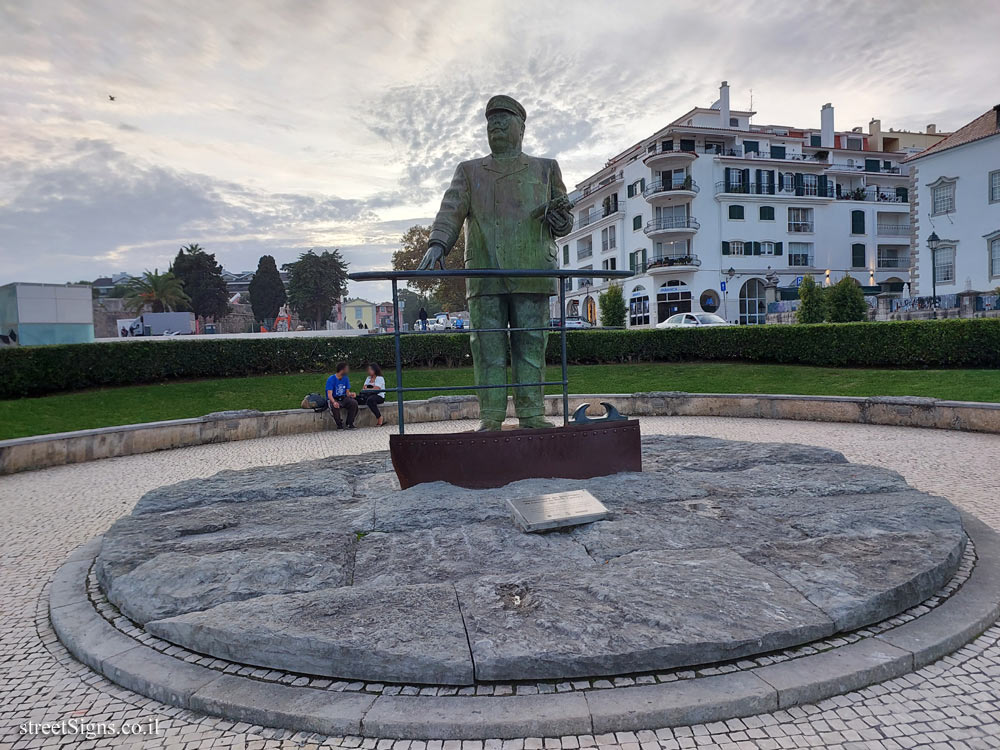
553,82,947,328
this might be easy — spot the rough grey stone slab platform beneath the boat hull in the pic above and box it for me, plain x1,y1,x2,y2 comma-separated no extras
96,437,965,685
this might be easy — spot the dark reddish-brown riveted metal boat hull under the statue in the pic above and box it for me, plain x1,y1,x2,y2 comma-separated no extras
389,419,642,490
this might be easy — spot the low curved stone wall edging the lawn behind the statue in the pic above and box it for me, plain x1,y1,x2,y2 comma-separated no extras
0,391,1000,475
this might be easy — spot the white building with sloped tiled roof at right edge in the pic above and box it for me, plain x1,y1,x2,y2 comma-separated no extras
906,104,1000,296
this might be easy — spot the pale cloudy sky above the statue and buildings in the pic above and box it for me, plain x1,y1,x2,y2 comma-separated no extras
0,0,1000,298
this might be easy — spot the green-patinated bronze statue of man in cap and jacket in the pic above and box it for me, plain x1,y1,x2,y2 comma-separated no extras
420,96,573,430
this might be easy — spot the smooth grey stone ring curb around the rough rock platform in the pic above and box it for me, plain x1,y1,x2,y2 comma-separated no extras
49,513,1000,739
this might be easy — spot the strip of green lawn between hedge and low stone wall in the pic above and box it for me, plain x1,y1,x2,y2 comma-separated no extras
0,363,1000,439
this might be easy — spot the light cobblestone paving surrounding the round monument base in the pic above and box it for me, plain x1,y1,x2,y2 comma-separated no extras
0,417,1000,750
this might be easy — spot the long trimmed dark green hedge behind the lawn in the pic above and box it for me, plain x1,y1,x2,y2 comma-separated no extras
0,318,1000,398
